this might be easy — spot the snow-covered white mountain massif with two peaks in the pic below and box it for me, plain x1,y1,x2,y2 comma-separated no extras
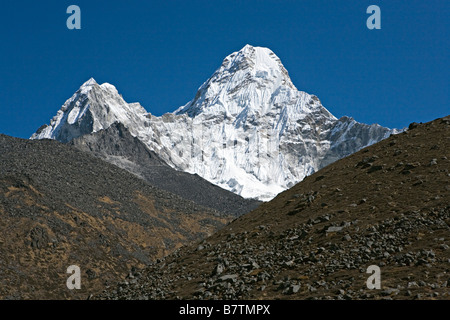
32,45,396,200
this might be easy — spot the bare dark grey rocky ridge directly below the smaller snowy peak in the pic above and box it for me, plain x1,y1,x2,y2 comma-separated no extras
69,122,261,217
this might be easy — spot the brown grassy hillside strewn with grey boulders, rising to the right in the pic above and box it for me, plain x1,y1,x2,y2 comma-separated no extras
99,116,450,299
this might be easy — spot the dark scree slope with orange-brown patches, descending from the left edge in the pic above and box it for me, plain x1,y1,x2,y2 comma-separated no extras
0,135,232,299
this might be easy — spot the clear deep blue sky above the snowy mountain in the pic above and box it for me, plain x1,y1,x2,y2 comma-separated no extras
0,0,450,138
